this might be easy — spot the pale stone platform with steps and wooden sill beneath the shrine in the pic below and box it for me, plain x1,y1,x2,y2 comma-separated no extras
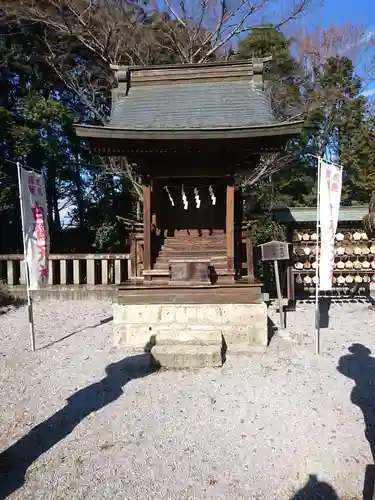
113,283,268,368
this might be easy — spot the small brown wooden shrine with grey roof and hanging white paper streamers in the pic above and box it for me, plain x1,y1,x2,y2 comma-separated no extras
76,59,301,368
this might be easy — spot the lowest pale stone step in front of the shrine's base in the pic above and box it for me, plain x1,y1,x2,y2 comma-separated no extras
151,343,223,369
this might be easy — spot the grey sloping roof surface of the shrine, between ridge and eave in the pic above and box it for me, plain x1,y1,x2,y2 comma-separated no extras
107,79,279,130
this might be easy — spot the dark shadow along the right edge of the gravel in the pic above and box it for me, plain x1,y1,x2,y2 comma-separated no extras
337,344,375,500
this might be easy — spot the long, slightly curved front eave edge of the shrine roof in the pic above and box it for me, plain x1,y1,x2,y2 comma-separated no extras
75,121,303,143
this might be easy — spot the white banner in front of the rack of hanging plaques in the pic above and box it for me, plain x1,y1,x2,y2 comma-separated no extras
319,160,342,291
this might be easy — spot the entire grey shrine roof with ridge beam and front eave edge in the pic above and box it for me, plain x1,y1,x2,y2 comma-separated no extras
76,58,301,144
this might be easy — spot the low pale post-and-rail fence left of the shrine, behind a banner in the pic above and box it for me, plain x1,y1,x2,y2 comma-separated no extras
0,254,132,287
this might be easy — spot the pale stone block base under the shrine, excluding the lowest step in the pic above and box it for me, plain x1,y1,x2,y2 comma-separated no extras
113,303,268,352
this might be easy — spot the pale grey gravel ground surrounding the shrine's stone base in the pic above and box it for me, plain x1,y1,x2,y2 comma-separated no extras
0,301,375,500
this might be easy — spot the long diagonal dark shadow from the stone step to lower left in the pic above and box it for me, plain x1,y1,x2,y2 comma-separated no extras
0,354,156,500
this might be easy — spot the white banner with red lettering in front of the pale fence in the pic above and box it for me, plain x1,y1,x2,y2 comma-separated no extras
18,168,49,290
